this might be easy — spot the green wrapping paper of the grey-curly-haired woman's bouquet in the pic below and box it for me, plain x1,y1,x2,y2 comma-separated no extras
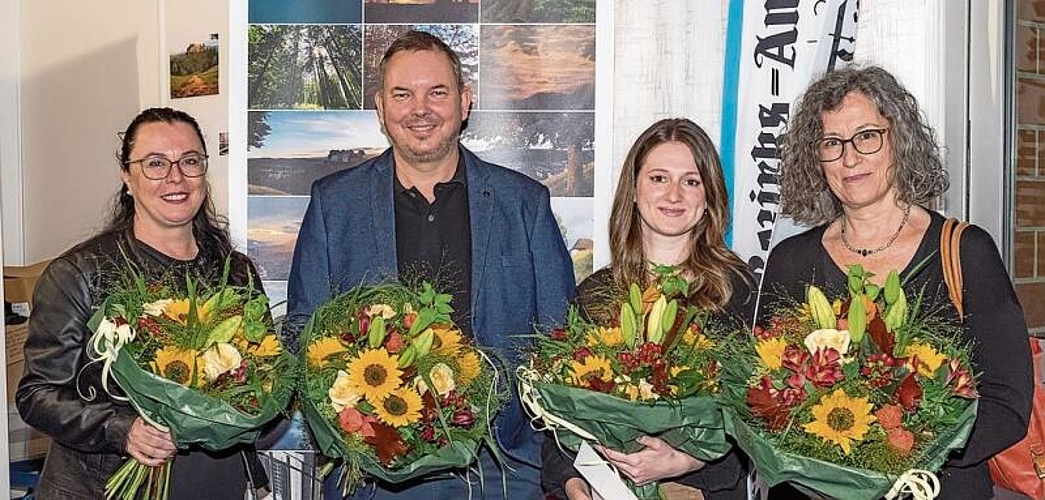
724,400,977,500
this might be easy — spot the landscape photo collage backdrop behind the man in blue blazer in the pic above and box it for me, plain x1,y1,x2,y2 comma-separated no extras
247,0,596,309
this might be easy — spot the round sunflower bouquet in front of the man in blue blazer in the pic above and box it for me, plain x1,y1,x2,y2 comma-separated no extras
302,282,507,492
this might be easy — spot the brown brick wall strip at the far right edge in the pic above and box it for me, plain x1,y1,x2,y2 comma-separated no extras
1012,0,1045,335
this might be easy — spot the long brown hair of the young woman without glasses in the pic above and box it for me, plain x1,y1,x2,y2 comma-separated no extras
609,118,748,309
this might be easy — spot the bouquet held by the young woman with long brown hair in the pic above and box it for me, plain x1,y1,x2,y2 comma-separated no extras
517,266,729,498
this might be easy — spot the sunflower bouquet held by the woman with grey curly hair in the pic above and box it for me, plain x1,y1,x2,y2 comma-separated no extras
723,266,977,500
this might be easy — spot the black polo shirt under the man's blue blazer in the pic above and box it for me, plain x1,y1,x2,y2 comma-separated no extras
394,158,471,334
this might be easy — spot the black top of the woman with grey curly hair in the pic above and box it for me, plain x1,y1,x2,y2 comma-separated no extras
759,211,1034,500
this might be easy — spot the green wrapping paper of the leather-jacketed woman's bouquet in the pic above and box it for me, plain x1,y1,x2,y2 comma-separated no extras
88,308,294,451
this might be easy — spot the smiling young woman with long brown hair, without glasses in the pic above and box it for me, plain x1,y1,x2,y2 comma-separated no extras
541,118,754,500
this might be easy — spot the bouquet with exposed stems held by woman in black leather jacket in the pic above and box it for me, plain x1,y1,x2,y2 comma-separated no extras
88,260,297,499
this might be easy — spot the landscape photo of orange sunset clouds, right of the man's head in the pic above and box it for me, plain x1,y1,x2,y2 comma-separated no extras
479,24,595,110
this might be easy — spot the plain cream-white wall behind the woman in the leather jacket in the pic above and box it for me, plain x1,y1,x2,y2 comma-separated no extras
0,0,228,265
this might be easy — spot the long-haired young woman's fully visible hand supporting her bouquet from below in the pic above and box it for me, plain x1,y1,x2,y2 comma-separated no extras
598,436,704,486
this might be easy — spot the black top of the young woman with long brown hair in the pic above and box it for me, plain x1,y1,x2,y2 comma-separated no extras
540,268,754,500
